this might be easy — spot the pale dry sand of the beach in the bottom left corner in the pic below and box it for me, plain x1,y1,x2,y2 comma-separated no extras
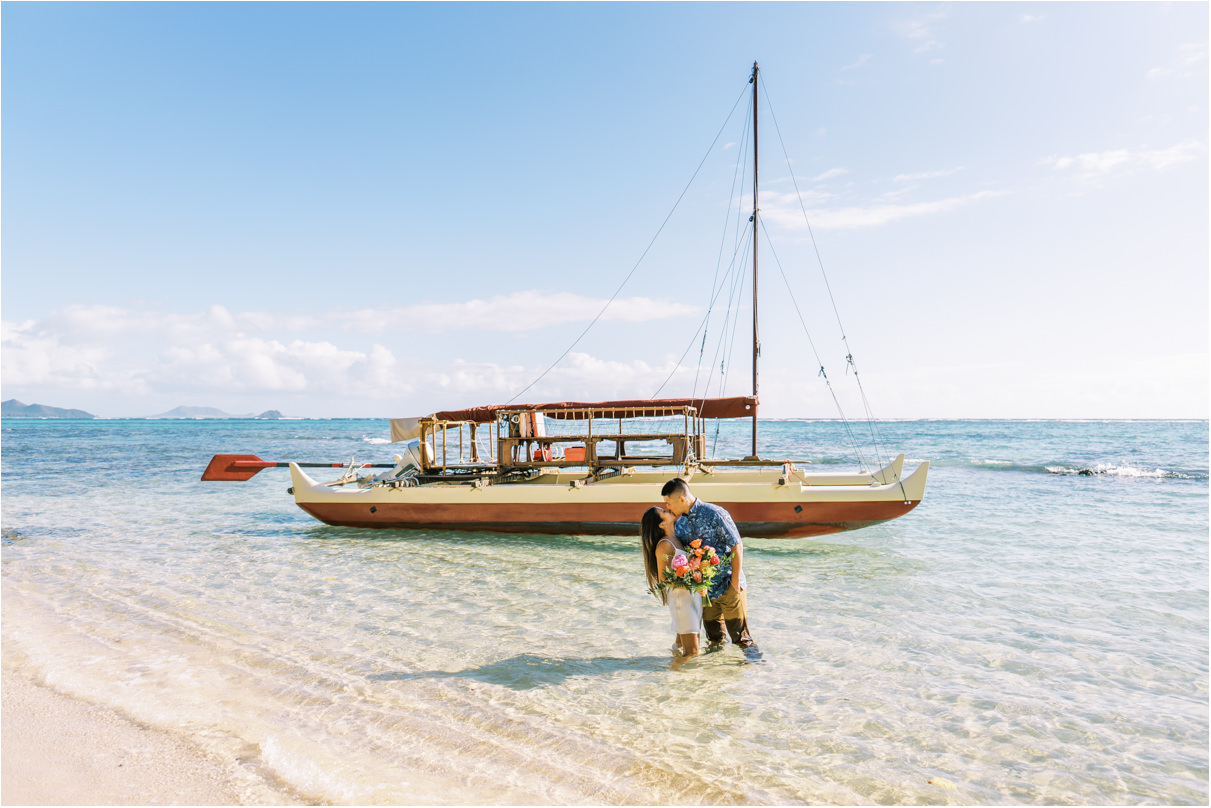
0,670,306,806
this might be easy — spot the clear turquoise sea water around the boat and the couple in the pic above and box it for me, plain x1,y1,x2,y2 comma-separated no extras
2,419,1209,804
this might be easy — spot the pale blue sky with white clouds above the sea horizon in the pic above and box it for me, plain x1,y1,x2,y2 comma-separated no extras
0,2,1209,419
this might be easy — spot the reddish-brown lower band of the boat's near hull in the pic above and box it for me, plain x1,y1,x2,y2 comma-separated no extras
299,502,918,538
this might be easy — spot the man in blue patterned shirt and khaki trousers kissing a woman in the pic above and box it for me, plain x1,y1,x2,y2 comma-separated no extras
660,477,756,648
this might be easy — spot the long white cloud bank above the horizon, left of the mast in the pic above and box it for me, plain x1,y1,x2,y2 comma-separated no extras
0,292,699,416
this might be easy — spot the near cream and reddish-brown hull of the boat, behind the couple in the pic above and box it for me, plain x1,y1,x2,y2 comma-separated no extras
291,463,929,538
